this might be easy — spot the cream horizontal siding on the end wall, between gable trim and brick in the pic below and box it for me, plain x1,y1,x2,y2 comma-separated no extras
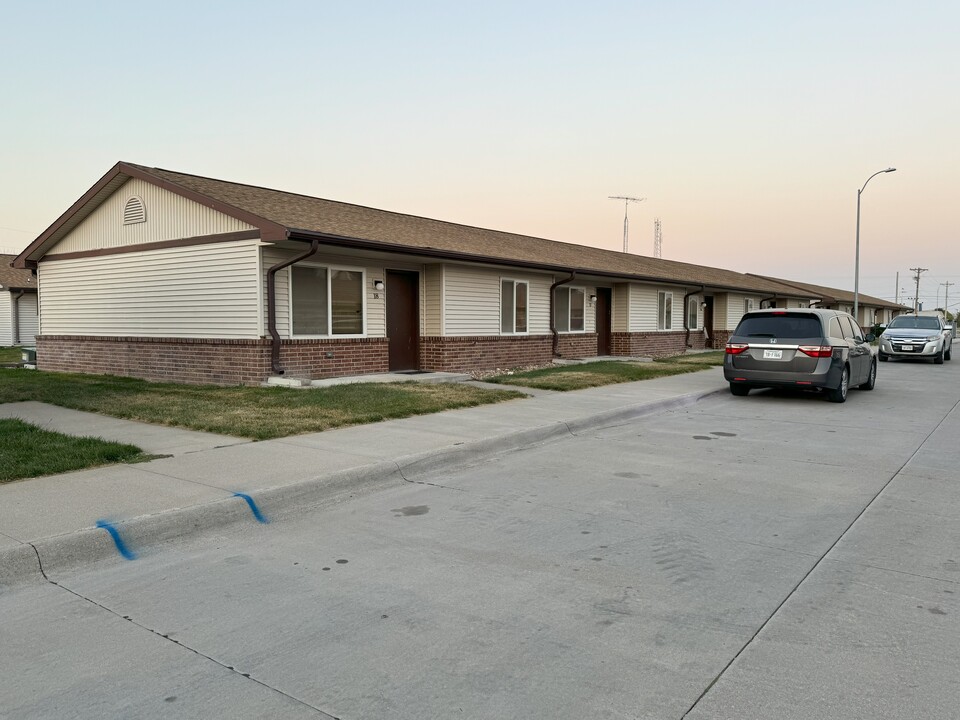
38,240,259,339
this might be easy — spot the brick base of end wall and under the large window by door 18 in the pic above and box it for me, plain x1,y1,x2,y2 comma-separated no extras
37,335,388,385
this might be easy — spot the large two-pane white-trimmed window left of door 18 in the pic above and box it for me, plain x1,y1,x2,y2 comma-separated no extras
290,265,366,337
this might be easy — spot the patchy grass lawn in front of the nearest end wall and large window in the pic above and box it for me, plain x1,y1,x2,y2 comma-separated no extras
0,368,524,440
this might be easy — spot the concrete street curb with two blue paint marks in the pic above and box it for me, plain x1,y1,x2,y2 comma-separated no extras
0,388,726,588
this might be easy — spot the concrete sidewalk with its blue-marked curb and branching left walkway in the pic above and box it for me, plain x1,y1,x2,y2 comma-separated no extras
0,368,726,587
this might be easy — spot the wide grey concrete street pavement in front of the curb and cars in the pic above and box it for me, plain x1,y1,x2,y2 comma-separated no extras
0,361,960,720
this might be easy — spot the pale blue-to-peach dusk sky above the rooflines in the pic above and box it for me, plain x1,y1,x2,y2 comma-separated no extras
0,0,960,308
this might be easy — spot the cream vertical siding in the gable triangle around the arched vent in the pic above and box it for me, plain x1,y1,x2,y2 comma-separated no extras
49,179,255,254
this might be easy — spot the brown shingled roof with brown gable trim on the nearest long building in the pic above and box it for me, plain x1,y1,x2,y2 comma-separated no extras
18,162,892,306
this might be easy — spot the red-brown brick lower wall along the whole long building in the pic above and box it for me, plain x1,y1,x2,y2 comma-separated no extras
37,330,712,385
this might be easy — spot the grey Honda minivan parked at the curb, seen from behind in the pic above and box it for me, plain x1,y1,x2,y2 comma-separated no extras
723,308,877,403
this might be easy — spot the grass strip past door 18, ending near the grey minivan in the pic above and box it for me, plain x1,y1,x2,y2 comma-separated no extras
488,351,723,391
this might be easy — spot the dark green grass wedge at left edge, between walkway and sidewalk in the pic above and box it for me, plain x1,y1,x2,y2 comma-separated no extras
0,419,151,483
